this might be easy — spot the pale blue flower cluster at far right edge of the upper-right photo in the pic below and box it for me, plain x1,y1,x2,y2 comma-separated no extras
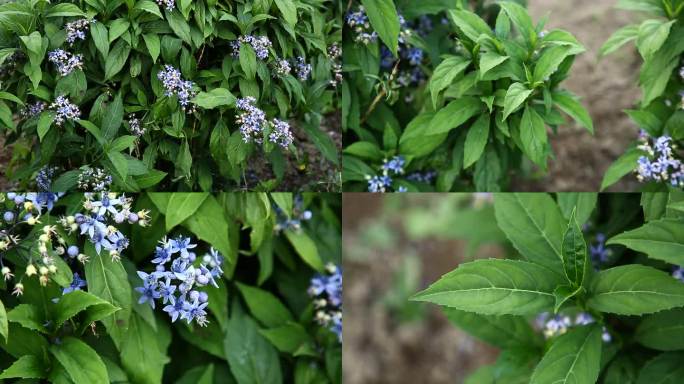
635,131,684,188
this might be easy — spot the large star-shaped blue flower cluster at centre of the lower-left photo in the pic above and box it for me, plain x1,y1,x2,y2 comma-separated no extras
135,237,223,326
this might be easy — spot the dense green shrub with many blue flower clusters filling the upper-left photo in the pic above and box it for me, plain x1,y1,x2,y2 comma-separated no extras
0,0,342,191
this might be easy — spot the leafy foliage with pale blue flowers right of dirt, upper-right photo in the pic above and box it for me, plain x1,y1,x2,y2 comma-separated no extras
601,0,684,190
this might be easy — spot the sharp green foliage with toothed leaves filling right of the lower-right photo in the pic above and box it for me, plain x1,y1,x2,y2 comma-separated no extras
413,192,684,384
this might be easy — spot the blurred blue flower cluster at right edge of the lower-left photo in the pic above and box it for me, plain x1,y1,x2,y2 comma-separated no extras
308,263,342,342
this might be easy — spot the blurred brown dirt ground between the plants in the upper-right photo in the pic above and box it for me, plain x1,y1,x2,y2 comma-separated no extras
513,0,641,191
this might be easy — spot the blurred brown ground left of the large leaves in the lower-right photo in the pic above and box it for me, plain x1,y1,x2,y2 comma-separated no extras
342,193,496,384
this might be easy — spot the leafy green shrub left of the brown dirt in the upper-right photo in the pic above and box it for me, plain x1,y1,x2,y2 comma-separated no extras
342,0,593,192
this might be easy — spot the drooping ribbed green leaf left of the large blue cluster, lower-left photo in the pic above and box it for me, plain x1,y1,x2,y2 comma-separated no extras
83,242,132,346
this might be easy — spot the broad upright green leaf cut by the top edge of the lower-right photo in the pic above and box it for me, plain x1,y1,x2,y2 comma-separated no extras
494,193,566,274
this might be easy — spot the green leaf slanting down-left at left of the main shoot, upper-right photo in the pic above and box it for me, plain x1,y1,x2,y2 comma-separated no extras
424,97,484,136
